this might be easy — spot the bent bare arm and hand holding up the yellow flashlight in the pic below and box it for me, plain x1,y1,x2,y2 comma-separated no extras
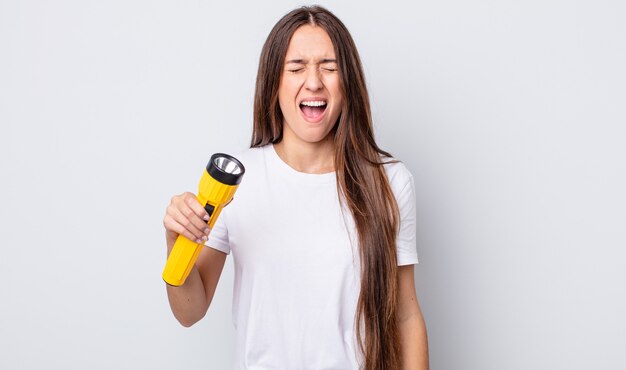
163,193,226,327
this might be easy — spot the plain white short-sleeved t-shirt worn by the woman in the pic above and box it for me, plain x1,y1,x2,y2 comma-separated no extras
207,145,417,370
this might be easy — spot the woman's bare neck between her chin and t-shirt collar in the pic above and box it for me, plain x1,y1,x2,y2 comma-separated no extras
274,135,335,174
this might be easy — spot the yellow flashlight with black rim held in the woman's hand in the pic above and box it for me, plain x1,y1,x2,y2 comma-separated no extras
163,153,246,286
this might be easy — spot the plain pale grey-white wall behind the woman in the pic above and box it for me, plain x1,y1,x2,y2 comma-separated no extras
0,0,626,370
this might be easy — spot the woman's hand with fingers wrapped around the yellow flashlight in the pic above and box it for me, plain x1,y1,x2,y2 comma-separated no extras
163,192,210,246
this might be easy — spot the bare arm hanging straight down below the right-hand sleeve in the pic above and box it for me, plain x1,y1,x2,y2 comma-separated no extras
398,265,428,370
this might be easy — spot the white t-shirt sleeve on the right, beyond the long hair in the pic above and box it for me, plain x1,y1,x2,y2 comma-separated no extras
392,170,418,266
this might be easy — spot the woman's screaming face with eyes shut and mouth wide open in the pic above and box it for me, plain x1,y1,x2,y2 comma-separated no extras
278,25,343,143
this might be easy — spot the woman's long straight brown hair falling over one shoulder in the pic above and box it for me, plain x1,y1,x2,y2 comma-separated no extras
251,6,400,370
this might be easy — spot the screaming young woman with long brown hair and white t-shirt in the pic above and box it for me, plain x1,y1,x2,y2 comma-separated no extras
164,7,428,370
